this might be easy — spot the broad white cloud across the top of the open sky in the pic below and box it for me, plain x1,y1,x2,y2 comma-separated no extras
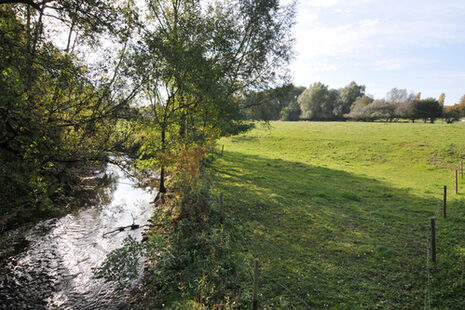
294,0,465,70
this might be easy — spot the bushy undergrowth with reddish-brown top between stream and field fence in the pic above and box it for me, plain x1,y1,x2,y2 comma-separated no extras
97,148,250,309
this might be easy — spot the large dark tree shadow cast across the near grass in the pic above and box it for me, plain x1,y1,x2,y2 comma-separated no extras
214,152,465,309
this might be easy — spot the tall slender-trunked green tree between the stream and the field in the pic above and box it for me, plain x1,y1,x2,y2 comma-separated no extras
134,0,294,194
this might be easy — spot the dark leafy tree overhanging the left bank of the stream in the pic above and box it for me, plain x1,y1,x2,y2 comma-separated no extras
0,0,136,223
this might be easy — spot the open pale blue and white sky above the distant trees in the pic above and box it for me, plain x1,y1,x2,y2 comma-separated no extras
290,0,465,105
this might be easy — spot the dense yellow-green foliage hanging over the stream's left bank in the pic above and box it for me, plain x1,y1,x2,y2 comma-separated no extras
0,2,137,225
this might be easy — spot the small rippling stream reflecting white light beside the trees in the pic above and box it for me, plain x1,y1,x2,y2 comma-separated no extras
0,165,154,310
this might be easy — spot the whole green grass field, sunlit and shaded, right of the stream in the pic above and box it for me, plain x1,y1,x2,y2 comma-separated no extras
213,122,465,309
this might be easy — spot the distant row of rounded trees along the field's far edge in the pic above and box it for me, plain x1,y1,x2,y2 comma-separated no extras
244,82,465,123
